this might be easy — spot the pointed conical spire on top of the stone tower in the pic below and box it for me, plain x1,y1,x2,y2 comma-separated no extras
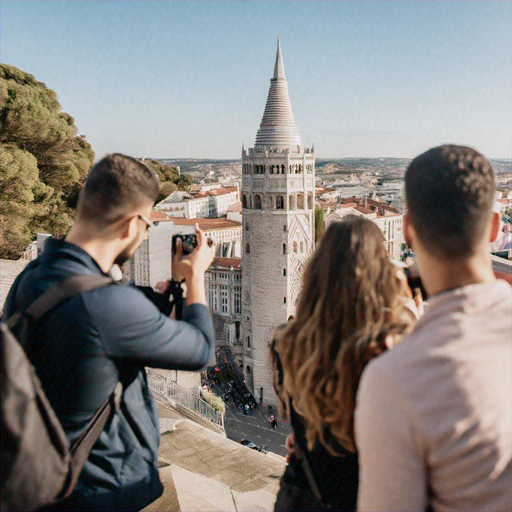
255,36,302,147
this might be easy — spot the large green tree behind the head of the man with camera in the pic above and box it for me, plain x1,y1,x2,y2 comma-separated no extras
0,64,94,258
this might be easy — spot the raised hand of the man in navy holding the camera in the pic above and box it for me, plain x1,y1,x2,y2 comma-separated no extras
172,224,215,286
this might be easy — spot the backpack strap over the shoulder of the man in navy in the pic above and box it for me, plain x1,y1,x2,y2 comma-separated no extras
6,274,114,329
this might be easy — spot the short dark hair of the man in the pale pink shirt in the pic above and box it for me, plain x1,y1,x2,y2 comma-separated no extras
405,145,495,259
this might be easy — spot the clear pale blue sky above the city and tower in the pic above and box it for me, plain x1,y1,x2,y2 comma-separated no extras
0,0,512,158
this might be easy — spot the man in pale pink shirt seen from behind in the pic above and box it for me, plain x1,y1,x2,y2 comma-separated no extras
355,146,512,511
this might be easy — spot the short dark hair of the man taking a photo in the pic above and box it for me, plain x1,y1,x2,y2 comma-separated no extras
77,153,159,225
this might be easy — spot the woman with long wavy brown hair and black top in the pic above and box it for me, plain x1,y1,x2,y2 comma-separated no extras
271,216,417,511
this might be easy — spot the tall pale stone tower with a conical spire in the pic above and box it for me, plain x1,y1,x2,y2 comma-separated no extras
242,38,315,404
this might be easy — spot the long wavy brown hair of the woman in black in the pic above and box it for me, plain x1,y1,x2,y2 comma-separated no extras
278,215,412,452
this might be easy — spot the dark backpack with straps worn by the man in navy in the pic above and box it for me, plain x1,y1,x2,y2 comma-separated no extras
1,275,122,512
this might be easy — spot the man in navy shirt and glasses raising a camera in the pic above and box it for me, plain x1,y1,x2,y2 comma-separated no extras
4,154,215,510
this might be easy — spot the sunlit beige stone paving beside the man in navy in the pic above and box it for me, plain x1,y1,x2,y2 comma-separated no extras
144,397,285,512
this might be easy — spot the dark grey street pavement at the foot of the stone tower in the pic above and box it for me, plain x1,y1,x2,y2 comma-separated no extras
224,405,292,457
